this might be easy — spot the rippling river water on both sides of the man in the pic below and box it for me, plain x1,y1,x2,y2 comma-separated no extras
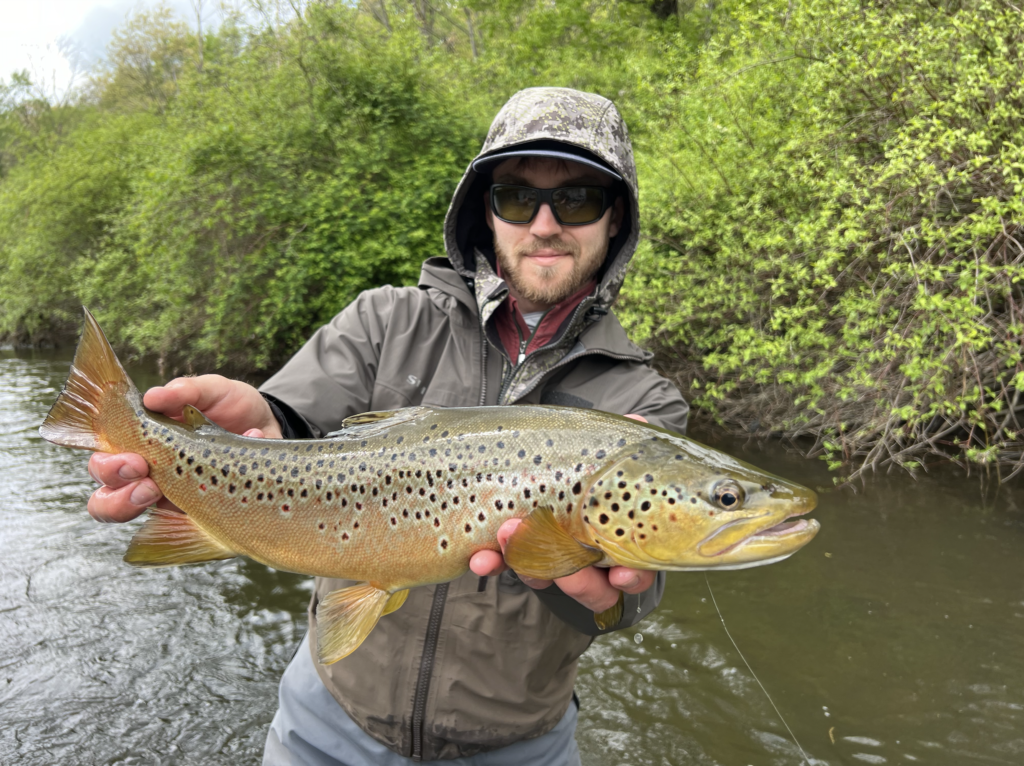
0,349,1024,766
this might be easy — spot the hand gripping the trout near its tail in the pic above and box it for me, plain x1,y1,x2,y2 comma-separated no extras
88,375,282,522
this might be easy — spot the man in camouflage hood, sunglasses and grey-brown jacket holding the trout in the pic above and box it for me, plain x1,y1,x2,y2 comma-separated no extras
89,88,687,766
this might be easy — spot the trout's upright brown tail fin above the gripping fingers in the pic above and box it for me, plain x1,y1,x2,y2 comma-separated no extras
39,308,135,450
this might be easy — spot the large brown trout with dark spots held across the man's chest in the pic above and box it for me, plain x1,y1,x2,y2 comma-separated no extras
39,311,818,664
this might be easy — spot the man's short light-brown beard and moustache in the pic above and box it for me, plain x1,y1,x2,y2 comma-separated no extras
495,237,609,306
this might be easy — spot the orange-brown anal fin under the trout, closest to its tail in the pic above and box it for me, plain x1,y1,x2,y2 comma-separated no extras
124,508,239,566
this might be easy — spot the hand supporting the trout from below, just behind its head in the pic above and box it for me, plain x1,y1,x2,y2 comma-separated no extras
469,415,656,612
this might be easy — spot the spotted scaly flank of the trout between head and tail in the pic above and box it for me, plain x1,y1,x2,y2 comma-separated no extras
128,408,649,588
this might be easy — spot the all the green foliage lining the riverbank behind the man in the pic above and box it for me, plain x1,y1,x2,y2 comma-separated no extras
0,0,1024,475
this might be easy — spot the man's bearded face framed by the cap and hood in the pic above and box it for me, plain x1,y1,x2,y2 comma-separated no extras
484,158,623,312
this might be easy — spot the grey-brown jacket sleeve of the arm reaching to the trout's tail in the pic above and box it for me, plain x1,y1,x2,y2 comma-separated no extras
260,287,397,438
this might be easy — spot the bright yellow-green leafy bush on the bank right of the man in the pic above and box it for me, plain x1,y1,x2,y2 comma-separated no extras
629,0,1024,479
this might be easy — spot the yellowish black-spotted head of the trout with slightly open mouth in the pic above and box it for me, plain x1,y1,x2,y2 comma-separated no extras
580,434,819,570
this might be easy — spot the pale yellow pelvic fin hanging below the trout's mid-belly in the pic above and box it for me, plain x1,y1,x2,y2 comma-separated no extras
316,583,391,665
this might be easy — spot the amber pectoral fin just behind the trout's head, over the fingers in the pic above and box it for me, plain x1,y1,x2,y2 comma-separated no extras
505,508,604,580
